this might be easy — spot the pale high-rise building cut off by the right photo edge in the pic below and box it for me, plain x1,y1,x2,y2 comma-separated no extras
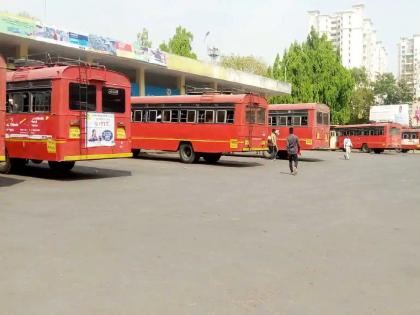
398,35,420,99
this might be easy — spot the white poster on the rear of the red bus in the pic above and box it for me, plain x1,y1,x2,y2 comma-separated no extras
86,112,115,148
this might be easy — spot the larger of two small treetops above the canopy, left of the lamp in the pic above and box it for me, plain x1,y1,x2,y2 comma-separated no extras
159,26,197,59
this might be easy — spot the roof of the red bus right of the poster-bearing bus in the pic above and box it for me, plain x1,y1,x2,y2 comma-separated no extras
131,94,267,104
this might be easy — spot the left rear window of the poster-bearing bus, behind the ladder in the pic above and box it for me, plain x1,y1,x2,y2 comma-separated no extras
69,83,96,111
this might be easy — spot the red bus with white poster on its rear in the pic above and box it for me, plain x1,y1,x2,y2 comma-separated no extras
1,62,132,173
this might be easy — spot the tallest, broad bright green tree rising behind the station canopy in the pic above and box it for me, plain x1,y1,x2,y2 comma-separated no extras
270,29,355,124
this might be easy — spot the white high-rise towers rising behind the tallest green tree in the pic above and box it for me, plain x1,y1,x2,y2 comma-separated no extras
308,5,387,80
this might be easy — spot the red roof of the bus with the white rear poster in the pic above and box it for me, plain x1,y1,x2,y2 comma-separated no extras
7,65,130,87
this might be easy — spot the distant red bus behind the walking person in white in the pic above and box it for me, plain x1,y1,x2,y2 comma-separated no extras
331,123,401,154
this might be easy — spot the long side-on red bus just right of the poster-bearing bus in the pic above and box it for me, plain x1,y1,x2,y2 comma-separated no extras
131,94,268,163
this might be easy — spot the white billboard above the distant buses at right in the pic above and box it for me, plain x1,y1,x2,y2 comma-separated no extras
369,104,410,126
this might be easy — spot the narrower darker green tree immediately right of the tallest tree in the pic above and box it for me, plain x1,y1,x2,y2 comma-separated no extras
350,68,375,123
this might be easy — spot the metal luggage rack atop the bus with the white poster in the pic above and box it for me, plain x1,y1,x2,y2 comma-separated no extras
7,53,106,70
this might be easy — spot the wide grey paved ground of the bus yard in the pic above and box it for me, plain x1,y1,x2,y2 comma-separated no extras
0,152,420,315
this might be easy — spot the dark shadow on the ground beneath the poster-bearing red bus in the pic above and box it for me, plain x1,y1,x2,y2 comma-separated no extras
7,163,131,181
